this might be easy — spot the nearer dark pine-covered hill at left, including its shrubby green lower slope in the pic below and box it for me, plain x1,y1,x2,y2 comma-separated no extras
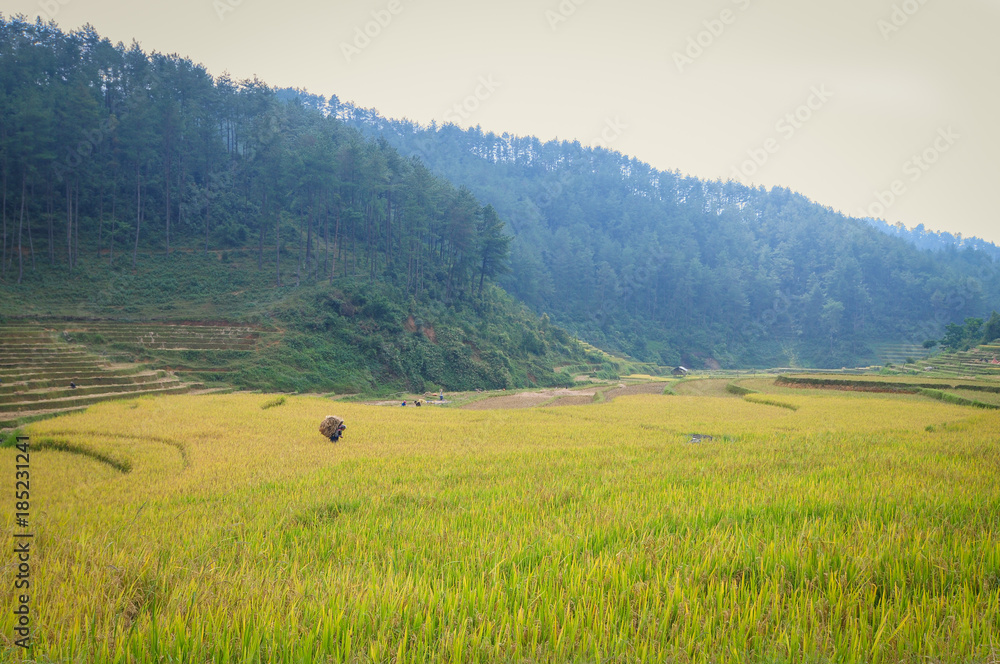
0,16,583,391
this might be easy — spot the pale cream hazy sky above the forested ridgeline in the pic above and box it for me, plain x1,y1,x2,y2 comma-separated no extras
0,0,1000,243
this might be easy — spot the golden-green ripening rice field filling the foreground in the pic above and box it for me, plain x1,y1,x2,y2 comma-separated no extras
0,391,1000,664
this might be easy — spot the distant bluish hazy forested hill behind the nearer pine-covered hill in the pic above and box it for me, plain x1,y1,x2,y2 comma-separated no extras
328,100,1000,367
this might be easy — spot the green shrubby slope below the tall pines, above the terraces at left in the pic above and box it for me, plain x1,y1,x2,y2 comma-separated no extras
0,252,602,393
